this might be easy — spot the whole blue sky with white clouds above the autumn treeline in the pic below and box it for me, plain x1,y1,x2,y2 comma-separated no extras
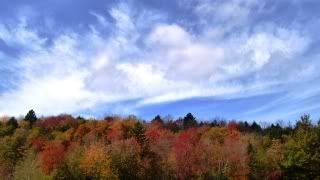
0,0,320,122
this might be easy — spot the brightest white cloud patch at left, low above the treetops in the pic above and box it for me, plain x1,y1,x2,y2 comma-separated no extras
0,74,96,115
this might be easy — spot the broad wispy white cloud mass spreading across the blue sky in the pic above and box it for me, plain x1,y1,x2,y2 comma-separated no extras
0,0,319,121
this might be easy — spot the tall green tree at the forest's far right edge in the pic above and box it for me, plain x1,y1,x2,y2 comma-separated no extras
281,115,320,179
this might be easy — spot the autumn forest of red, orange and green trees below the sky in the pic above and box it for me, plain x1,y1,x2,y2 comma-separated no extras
0,110,320,180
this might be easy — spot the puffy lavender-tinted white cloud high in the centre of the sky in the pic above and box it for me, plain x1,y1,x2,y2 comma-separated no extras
146,25,224,80
